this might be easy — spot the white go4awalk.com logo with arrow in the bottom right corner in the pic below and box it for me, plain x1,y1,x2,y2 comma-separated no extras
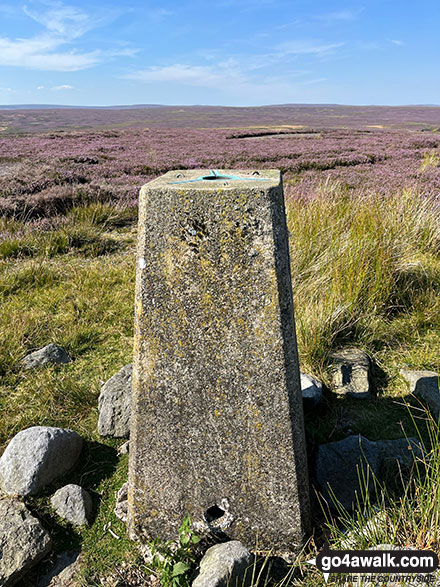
307,544,439,582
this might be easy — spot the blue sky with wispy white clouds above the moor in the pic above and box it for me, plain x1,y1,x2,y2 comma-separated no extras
0,0,440,106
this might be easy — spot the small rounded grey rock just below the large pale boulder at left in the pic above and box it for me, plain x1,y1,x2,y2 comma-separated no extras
50,484,93,526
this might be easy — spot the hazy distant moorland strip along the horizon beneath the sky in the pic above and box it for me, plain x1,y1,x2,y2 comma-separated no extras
0,104,440,137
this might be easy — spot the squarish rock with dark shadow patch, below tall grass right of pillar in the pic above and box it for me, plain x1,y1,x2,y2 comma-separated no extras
329,348,371,399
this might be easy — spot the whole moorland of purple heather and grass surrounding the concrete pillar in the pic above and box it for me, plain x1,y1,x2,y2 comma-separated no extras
0,106,440,587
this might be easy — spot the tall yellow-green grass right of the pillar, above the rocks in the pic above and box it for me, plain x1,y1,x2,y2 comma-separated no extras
287,183,440,380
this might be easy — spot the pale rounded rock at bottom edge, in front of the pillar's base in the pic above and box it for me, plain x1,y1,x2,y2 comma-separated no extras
192,540,253,587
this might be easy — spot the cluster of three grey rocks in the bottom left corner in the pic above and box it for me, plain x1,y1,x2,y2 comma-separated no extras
0,426,86,587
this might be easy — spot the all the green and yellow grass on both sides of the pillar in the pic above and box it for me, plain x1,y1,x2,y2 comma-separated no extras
0,187,440,587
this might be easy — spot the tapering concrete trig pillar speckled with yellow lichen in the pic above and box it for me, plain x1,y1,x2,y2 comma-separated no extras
129,170,309,554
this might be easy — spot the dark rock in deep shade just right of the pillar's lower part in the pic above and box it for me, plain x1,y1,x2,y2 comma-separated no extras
315,436,380,509
